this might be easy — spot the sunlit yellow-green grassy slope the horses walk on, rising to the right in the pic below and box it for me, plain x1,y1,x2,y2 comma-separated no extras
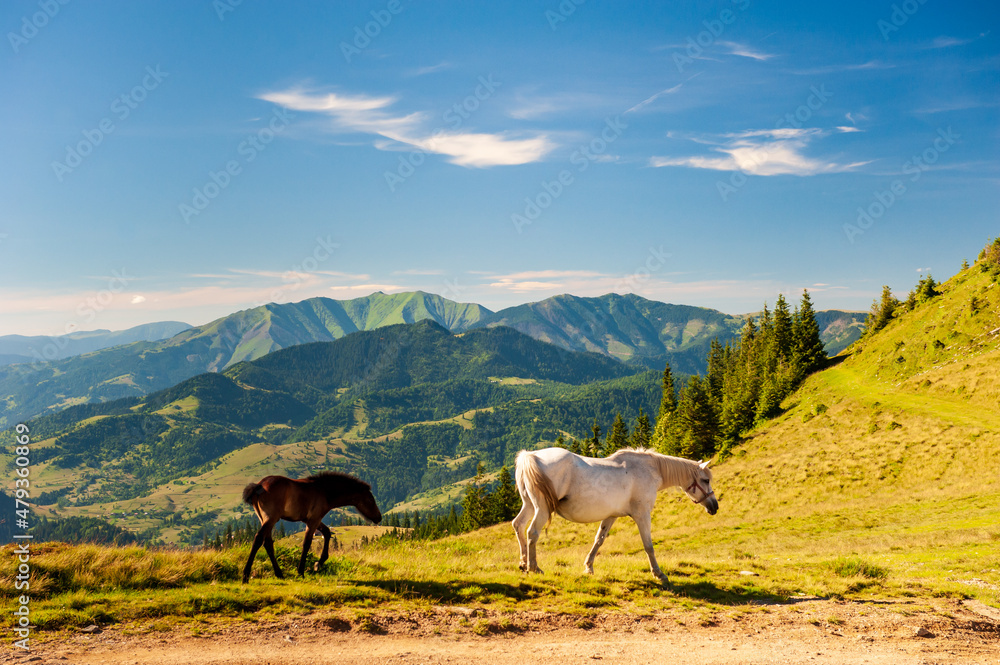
0,253,1000,634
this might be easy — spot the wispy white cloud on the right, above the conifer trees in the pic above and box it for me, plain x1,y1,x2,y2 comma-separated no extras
649,127,869,176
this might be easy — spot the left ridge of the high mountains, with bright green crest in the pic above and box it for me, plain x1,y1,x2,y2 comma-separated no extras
0,291,489,427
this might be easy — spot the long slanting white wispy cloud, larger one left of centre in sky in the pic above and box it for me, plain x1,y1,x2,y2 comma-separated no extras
260,88,556,168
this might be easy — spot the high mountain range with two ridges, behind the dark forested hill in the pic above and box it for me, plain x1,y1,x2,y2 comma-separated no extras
0,291,864,427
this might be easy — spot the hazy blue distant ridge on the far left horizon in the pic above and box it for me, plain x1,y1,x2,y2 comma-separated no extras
0,321,191,365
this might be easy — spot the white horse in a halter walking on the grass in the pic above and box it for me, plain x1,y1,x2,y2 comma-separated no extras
512,448,719,582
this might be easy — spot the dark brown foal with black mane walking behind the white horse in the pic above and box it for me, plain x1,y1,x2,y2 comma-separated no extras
243,471,382,584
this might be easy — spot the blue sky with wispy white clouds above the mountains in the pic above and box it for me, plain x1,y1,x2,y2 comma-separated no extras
0,0,1000,334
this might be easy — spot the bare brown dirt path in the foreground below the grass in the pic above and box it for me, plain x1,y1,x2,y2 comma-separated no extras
9,600,1000,665
